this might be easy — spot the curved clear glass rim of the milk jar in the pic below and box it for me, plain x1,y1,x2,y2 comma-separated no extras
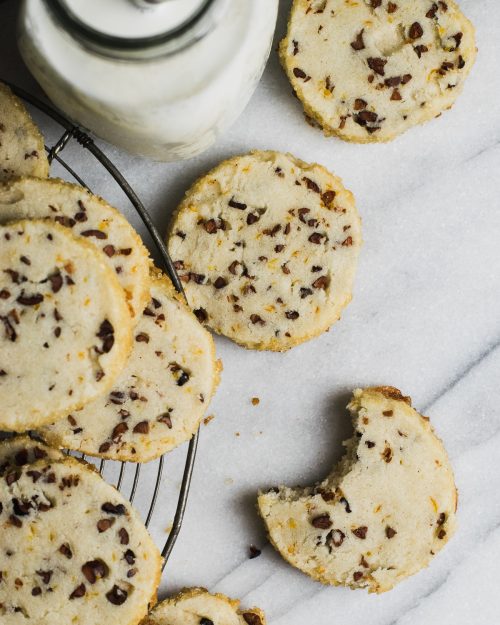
44,0,219,58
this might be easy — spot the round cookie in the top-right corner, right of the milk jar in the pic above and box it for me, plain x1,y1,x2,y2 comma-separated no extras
280,0,476,143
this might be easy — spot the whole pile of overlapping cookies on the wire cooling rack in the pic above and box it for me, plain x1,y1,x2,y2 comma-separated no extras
0,85,225,625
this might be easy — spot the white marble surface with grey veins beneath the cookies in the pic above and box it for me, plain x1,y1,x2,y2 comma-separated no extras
0,0,500,625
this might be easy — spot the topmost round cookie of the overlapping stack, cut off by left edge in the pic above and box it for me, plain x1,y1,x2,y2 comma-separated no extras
0,220,132,431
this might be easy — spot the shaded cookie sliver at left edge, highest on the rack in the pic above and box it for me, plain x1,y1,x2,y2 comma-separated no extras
0,82,49,182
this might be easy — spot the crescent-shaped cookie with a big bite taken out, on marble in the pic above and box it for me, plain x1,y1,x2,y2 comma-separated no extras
258,387,457,593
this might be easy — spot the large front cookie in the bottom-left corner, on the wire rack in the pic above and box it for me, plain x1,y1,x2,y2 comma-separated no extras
0,458,161,625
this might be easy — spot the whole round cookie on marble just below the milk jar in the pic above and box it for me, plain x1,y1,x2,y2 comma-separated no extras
169,152,361,351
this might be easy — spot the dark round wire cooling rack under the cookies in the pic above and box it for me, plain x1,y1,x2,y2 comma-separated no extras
2,80,199,566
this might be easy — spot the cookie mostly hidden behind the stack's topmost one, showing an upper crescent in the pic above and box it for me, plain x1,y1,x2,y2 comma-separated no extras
0,178,150,317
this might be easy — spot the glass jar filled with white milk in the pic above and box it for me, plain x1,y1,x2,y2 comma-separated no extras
19,0,278,161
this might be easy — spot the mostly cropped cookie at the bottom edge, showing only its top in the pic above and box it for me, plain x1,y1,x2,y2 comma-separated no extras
143,588,266,625
